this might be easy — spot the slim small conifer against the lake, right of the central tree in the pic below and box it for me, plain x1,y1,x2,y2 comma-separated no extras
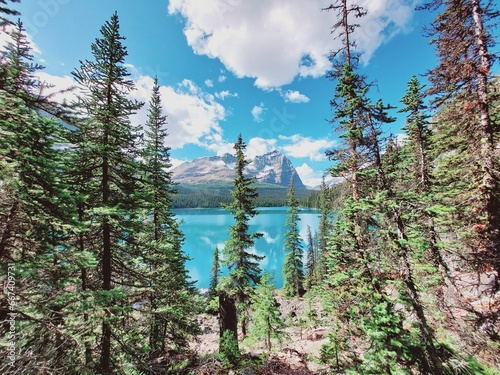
283,179,304,297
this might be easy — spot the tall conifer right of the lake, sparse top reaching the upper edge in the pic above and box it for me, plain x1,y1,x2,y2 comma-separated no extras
318,0,440,374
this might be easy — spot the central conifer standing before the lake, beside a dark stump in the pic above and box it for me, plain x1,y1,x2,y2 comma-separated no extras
219,134,263,348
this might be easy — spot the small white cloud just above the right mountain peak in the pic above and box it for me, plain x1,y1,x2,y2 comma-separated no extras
279,134,336,161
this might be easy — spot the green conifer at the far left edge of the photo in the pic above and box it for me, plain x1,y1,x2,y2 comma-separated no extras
0,22,77,373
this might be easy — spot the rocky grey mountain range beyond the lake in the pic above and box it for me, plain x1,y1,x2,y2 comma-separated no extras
172,151,307,190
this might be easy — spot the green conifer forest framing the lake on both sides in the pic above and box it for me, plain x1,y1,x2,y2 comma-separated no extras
0,0,500,375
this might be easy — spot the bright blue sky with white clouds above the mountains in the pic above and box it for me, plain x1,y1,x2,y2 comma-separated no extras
4,0,442,185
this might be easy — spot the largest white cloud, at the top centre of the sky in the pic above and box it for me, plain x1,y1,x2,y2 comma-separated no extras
168,0,417,89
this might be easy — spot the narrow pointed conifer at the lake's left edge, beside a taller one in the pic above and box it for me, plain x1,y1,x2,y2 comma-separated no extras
138,78,197,358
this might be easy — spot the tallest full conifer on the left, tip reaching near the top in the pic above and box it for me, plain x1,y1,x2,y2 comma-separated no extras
73,13,142,374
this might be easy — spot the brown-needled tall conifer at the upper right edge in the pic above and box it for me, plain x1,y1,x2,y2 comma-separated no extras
422,0,500,289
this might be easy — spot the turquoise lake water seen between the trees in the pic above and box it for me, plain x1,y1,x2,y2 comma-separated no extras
173,207,319,289
